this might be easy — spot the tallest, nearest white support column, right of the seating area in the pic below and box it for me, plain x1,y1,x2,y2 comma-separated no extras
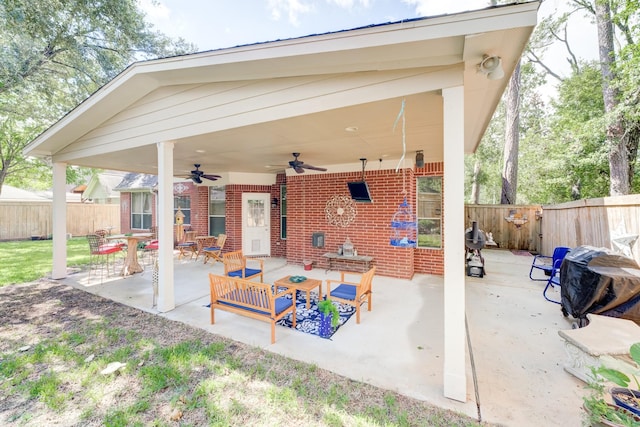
442,86,467,402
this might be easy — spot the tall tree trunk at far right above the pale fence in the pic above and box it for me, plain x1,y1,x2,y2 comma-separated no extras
595,0,631,196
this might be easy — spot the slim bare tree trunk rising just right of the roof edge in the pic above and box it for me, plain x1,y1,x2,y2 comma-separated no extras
500,62,520,205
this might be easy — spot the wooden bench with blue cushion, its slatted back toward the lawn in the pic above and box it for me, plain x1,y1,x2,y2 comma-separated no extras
209,273,296,344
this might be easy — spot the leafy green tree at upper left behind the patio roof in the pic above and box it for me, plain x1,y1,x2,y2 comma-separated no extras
0,0,195,192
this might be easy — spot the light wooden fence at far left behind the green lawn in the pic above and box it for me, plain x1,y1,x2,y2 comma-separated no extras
0,202,120,240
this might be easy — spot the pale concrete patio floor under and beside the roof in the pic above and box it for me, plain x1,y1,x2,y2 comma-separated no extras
63,249,587,427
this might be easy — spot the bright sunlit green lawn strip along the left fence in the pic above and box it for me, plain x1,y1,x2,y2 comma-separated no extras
0,237,89,286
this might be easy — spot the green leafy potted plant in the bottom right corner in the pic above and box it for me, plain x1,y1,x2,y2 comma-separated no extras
583,343,640,427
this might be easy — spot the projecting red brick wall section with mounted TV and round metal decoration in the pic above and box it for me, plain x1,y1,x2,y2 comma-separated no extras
287,169,415,278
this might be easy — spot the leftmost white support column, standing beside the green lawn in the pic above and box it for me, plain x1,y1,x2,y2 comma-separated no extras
51,162,67,279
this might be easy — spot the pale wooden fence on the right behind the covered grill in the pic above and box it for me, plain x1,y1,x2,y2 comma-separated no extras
541,194,640,268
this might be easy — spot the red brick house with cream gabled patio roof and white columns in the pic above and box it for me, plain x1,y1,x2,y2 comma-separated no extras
24,1,540,401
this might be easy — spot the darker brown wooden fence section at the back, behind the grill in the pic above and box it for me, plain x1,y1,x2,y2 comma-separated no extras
465,205,542,253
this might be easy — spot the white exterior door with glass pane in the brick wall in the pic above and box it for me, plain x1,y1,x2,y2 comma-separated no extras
242,193,271,256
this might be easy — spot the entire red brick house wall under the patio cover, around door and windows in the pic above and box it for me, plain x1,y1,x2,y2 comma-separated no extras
120,162,444,278
